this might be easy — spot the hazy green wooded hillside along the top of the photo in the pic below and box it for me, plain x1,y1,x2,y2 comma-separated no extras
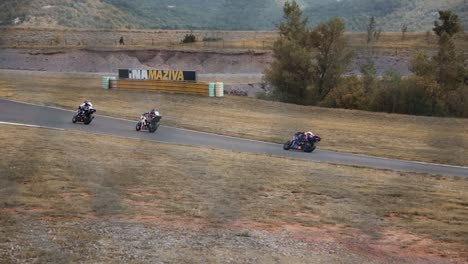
0,0,468,31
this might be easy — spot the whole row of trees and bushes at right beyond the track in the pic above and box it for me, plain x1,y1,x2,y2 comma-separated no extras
262,0,468,117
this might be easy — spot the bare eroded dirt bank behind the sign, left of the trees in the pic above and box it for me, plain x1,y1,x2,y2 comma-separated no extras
0,49,272,74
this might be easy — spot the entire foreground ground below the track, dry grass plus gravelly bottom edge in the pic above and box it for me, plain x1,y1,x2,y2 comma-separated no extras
0,125,468,263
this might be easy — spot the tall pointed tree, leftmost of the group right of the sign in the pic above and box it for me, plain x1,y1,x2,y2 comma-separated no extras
265,0,312,104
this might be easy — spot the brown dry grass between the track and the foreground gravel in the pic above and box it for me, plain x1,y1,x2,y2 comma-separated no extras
0,125,468,261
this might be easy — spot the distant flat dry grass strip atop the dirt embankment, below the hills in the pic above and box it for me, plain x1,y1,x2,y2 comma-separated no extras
0,27,468,56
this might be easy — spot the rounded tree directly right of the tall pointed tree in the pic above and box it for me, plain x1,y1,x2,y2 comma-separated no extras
310,18,354,102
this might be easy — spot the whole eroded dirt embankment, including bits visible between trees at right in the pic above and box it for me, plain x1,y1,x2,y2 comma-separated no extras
0,49,410,96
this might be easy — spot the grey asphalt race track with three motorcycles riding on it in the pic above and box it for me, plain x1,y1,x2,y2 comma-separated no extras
0,99,468,177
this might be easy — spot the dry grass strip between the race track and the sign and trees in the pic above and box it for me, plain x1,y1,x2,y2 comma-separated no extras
0,72,468,166
